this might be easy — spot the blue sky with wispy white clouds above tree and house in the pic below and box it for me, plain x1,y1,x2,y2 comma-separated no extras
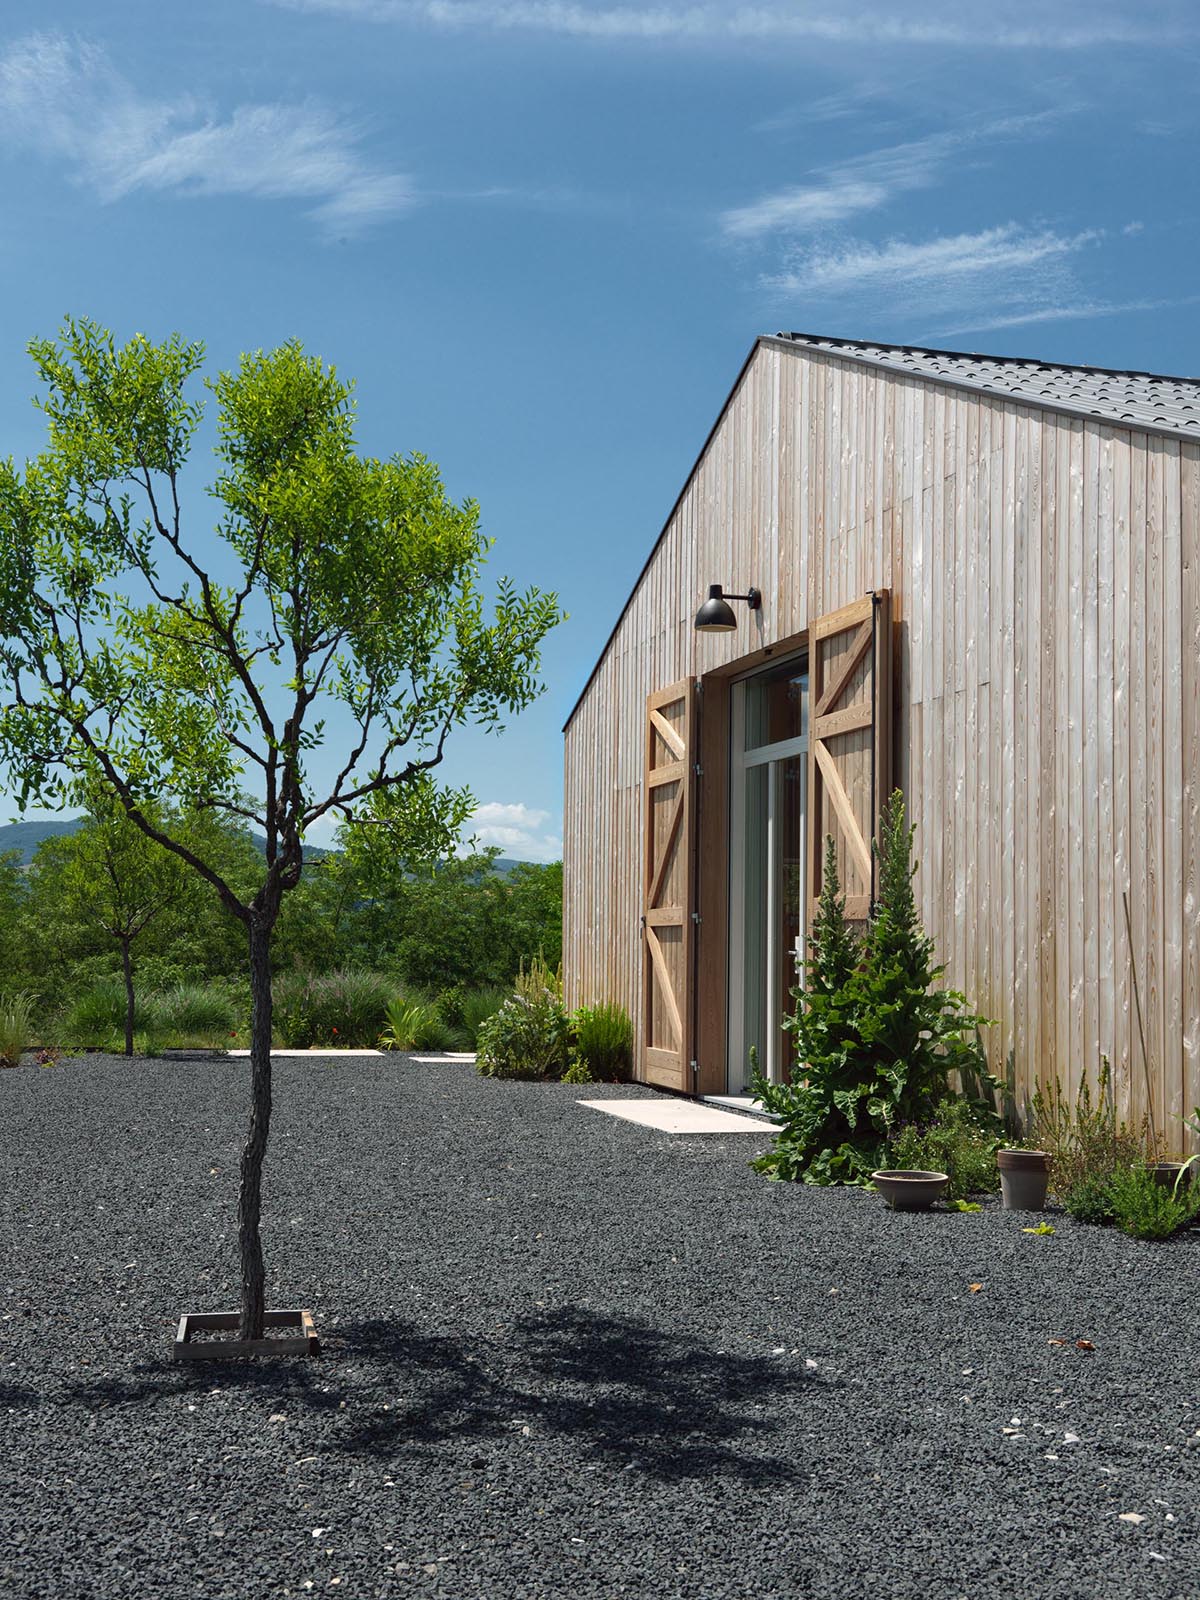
0,0,1200,859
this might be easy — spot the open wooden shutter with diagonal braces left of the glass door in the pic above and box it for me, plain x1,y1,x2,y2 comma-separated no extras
642,678,696,1093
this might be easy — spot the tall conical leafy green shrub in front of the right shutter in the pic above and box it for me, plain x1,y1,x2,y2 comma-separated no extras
752,790,1002,1182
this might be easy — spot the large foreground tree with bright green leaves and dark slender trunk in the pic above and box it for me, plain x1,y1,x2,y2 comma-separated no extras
0,320,560,1339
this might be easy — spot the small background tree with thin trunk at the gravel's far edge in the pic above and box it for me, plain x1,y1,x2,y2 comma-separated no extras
35,784,195,1056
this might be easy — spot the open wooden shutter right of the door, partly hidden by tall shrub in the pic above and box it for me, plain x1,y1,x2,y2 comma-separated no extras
808,589,891,920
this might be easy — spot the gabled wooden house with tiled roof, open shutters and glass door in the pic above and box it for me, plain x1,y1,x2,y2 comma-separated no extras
563,334,1200,1147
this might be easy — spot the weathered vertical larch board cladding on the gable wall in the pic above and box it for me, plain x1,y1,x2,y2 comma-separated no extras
563,341,1200,1147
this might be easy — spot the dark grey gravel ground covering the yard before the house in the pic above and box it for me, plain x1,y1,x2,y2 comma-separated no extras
0,1056,1200,1600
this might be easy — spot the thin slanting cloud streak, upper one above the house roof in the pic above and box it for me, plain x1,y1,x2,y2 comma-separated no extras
720,109,1066,238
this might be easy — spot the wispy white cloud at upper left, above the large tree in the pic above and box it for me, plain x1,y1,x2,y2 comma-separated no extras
0,34,414,234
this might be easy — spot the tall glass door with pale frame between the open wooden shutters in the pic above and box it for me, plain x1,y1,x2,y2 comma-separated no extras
728,659,808,1094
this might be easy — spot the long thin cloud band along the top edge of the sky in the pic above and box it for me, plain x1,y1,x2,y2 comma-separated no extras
269,0,1194,50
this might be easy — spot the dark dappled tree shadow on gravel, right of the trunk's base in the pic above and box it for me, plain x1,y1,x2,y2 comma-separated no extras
338,1309,829,1483
